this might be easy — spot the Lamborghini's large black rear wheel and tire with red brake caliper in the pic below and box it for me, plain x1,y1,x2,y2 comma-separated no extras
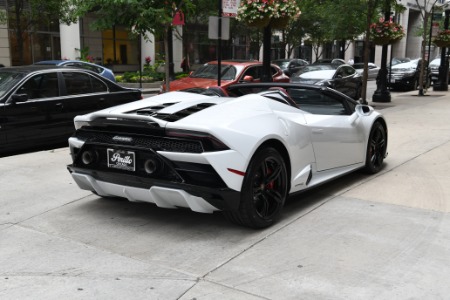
224,147,288,228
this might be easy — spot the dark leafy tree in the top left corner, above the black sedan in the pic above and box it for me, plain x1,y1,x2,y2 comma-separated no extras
0,0,75,65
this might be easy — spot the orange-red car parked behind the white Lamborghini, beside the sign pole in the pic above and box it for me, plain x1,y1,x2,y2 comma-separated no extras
164,61,289,91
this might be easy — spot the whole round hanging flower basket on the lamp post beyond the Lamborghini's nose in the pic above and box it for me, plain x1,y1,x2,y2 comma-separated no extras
369,18,405,45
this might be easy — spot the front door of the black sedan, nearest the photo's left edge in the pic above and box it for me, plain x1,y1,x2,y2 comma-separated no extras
0,73,62,149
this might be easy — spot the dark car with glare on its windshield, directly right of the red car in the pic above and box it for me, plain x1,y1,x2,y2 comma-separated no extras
290,64,362,100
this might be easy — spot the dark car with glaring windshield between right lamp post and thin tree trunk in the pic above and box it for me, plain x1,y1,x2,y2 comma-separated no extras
388,58,430,90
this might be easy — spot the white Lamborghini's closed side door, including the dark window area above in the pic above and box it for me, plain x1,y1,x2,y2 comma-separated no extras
294,90,365,171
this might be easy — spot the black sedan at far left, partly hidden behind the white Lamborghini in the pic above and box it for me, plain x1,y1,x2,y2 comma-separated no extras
0,65,141,153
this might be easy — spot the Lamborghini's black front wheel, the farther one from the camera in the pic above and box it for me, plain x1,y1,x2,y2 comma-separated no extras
365,122,387,174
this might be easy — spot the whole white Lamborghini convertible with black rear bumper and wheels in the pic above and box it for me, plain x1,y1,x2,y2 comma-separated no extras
68,83,388,228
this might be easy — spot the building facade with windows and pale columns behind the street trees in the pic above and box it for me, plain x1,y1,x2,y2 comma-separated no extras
0,0,443,72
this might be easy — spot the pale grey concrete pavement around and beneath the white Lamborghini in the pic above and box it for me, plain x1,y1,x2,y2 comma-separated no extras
0,82,450,300
